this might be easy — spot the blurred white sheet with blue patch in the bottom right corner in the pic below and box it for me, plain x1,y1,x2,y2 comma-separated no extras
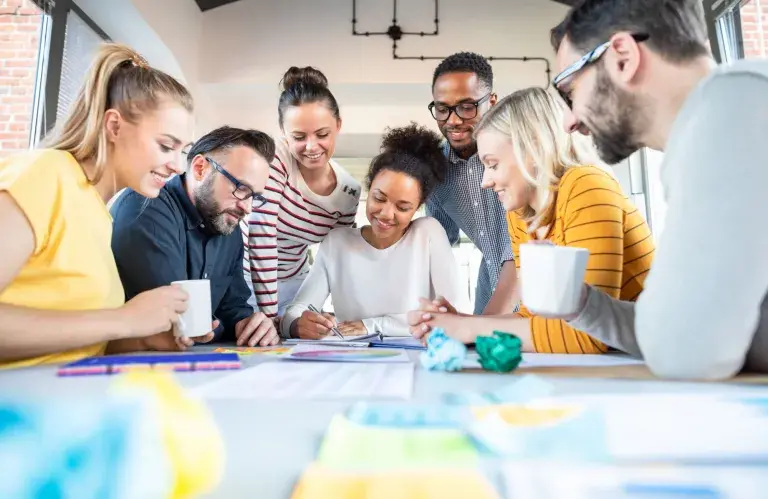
502,461,768,499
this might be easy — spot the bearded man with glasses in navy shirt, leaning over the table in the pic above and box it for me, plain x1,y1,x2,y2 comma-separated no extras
111,127,279,350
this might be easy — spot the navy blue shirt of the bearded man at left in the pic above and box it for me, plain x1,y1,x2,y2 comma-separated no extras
110,175,254,341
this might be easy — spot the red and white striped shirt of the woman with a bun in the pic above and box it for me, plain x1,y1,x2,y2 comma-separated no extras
241,142,360,317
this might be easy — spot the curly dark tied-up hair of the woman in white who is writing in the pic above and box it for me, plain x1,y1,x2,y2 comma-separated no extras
366,122,448,204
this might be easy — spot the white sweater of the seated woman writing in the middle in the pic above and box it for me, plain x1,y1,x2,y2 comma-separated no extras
280,217,469,337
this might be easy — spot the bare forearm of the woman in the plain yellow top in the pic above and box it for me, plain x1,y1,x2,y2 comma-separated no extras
0,304,129,360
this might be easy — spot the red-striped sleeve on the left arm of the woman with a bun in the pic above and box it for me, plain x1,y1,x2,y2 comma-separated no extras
245,157,288,317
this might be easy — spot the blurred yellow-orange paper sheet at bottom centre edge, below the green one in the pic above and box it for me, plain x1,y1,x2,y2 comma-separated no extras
291,463,499,499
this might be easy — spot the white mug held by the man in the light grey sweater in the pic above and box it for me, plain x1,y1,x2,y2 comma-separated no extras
520,244,589,317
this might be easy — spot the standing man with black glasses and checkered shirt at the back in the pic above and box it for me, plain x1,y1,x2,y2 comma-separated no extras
416,52,516,315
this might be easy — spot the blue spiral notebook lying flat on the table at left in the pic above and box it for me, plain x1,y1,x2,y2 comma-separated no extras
56,353,242,376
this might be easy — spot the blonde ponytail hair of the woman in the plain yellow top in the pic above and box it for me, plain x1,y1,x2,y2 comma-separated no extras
43,43,194,184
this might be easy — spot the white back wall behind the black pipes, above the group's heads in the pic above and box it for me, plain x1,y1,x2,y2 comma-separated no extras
200,0,566,156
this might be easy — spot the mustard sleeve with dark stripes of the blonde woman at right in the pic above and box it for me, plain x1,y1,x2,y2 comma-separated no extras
531,172,624,354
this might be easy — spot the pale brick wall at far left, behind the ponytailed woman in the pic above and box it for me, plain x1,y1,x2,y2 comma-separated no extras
0,0,42,158
